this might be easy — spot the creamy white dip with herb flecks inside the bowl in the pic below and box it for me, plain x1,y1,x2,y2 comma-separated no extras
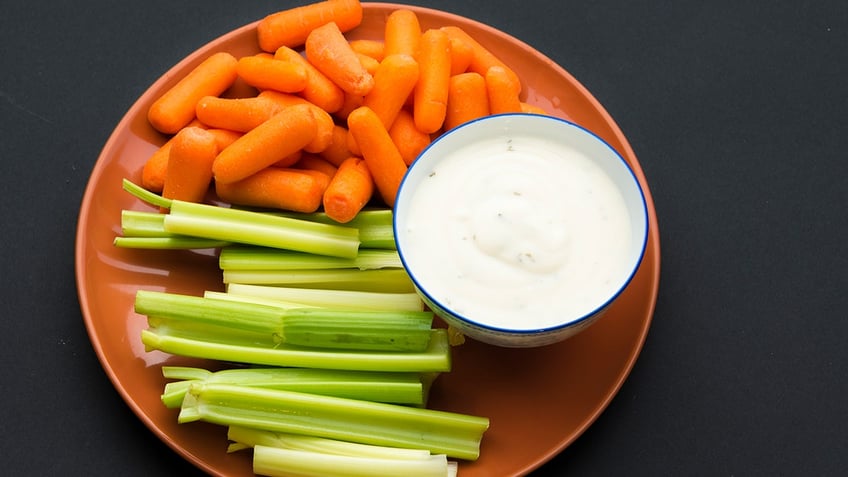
398,132,632,330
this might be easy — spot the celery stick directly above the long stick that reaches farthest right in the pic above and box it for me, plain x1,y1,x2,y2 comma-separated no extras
162,367,428,408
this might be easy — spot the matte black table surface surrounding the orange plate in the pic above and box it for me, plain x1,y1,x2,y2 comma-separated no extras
0,0,848,476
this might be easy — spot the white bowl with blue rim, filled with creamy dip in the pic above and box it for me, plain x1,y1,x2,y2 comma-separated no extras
394,113,648,348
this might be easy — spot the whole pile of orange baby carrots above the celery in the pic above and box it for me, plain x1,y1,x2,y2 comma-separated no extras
142,0,544,223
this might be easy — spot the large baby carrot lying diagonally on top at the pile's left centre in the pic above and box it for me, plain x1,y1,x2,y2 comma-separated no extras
212,105,316,184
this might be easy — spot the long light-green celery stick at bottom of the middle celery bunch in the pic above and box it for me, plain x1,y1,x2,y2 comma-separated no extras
141,329,451,373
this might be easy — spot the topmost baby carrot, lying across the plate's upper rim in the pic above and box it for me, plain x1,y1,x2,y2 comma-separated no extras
256,0,362,52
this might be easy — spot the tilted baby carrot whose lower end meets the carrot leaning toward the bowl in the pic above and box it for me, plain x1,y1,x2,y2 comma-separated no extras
362,53,423,129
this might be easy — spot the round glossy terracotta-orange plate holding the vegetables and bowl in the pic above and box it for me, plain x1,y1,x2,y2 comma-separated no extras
76,3,660,477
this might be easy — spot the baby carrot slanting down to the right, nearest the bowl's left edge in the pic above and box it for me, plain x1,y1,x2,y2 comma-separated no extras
347,106,406,207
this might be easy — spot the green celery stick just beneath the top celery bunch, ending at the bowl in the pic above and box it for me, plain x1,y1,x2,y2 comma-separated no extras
219,247,403,270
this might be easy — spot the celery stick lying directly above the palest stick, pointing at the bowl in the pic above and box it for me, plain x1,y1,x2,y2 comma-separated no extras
223,268,415,293
